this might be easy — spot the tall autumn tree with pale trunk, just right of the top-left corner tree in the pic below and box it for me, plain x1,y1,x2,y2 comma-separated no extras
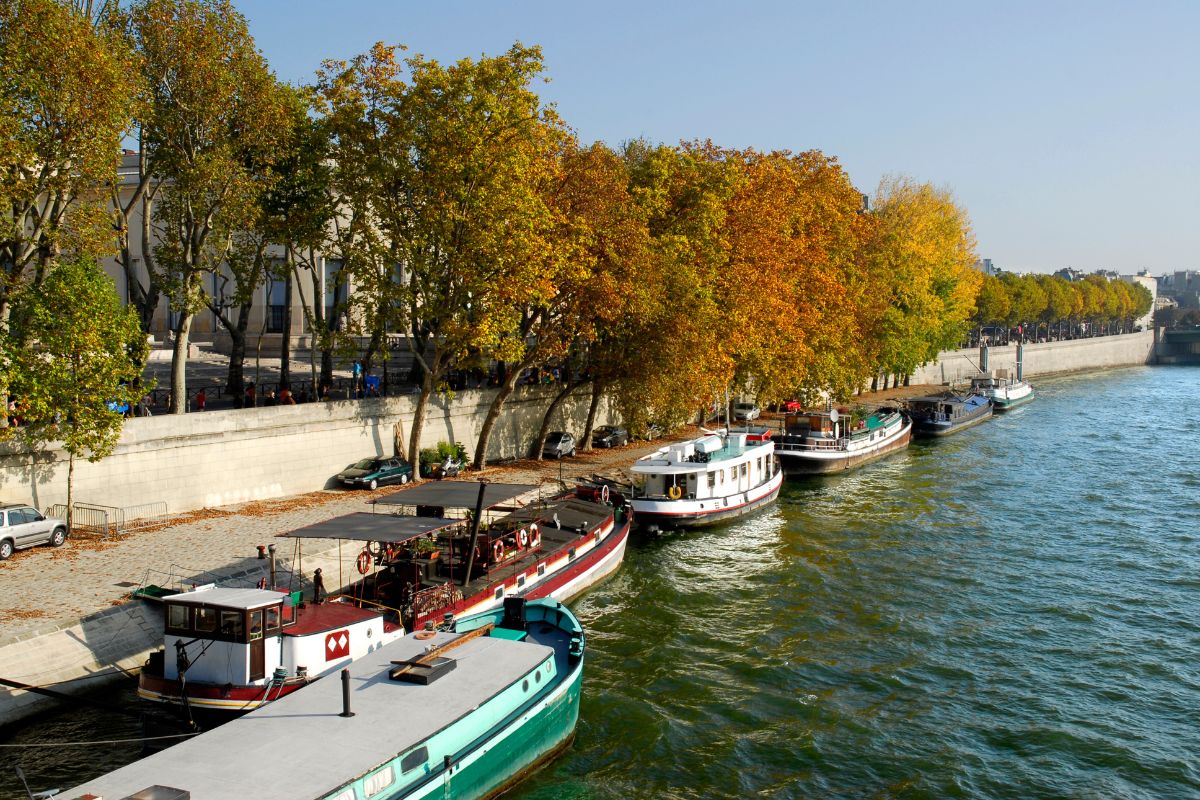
132,0,287,414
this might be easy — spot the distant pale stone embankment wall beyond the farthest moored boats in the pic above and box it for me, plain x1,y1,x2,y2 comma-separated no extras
912,331,1154,384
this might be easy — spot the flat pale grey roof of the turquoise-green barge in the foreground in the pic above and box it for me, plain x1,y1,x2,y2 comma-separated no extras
68,632,554,800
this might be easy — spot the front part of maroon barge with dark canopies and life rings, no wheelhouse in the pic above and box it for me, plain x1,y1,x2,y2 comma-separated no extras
283,481,630,631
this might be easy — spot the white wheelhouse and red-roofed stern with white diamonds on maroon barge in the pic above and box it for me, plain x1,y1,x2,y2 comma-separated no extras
138,585,404,716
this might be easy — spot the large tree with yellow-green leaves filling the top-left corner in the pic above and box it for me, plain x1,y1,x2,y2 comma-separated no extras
0,0,131,425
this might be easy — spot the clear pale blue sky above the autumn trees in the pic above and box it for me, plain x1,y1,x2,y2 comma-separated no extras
234,0,1200,275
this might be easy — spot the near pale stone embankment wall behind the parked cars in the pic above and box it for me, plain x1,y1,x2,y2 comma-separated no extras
0,387,610,513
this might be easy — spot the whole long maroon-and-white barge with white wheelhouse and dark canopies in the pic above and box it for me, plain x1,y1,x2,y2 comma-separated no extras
138,481,629,712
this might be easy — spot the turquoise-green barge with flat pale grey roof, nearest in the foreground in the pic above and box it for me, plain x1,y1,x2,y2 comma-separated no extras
69,597,584,800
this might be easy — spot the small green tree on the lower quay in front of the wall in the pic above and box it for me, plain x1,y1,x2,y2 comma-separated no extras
4,259,152,528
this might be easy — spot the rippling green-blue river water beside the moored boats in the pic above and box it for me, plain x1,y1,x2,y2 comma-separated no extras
0,367,1200,800
